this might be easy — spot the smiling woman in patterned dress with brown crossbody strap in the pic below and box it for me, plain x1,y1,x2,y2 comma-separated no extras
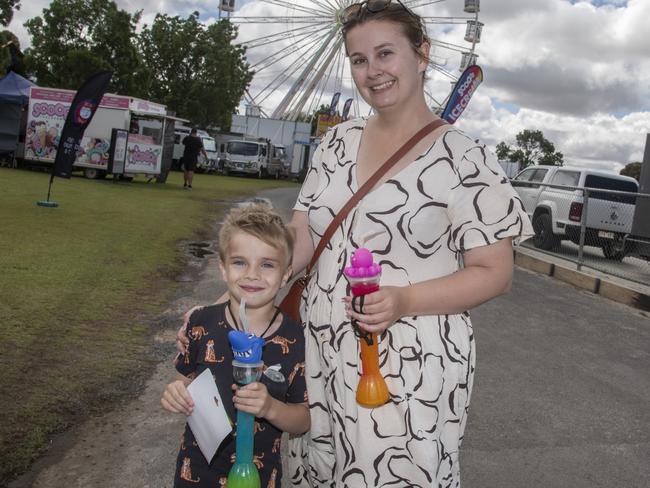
291,0,531,487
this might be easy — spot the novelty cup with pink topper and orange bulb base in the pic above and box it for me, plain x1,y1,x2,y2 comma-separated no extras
343,247,390,408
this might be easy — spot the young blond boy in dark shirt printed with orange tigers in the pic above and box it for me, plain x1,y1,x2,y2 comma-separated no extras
161,204,309,488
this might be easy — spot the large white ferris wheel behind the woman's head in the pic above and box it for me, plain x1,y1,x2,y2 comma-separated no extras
220,0,483,120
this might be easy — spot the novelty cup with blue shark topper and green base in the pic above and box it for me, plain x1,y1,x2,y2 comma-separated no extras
227,330,264,488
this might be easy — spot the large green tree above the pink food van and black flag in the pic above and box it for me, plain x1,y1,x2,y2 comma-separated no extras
24,0,142,96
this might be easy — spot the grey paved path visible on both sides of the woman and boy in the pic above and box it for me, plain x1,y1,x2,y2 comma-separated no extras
10,190,650,488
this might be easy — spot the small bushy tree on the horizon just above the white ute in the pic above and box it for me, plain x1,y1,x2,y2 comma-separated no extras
497,129,564,169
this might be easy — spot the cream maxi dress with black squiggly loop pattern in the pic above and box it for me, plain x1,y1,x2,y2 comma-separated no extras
294,119,532,488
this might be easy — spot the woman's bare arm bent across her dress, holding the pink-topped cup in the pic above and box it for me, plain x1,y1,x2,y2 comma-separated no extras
346,238,514,332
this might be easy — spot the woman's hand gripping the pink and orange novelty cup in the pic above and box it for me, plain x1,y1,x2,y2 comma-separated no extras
343,286,408,334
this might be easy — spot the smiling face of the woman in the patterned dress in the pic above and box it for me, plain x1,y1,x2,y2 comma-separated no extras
346,20,429,111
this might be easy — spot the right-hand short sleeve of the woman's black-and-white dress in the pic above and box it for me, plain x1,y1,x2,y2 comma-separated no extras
448,133,533,252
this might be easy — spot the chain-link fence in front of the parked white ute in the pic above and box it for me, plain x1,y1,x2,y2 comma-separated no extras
522,185,650,286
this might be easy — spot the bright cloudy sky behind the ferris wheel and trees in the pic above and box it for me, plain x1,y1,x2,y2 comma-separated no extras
9,0,650,172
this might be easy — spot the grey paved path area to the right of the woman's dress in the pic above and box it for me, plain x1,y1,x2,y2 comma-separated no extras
461,269,650,488
